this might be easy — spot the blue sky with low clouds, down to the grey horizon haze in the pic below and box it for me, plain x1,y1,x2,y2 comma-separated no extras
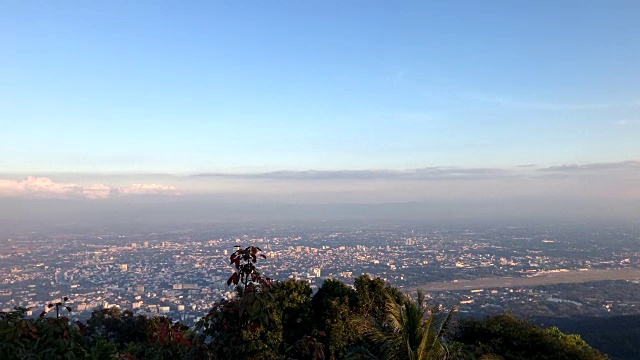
0,0,640,224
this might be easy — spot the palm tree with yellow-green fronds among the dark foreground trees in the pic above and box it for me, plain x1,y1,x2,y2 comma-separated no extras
349,291,456,360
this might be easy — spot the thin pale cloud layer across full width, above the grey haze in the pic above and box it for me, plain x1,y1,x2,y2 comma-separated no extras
0,160,640,203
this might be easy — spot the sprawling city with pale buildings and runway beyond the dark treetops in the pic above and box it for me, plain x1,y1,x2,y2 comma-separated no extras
5,223,640,324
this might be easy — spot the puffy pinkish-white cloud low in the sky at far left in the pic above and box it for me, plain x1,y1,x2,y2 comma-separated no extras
0,176,180,200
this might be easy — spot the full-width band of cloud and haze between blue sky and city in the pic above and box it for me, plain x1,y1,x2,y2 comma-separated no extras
0,160,640,231
